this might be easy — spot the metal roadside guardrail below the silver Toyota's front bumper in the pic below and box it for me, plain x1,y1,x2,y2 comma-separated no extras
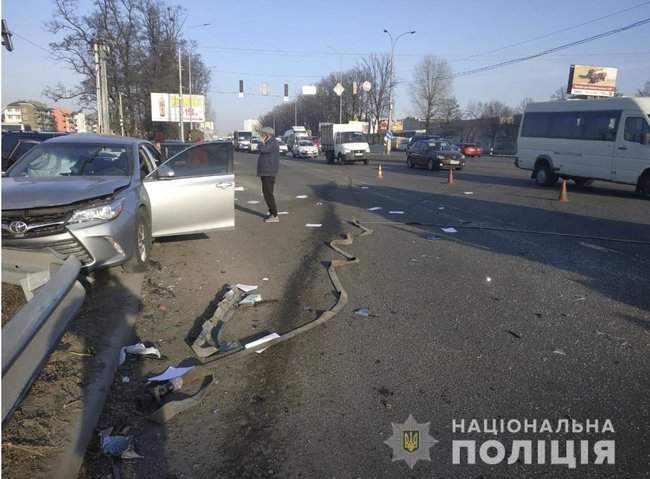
2,255,86,423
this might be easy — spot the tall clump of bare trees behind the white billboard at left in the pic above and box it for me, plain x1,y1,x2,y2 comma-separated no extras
44,0,210,135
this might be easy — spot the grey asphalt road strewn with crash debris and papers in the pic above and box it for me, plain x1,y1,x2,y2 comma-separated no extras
82,154,650,479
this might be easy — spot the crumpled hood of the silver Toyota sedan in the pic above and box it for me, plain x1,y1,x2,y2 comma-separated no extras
2,176,131,210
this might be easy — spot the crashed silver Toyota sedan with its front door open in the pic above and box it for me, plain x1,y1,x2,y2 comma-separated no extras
2,134,235,271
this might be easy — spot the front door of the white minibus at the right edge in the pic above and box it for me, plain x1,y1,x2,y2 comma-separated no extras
612,112,650,185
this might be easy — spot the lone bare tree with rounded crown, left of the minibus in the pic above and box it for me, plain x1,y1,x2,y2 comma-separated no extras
411,55,452,128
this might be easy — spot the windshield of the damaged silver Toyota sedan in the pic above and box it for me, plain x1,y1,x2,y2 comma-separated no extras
8,142,131,177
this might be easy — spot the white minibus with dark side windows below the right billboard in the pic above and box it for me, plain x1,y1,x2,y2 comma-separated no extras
515,97,650,197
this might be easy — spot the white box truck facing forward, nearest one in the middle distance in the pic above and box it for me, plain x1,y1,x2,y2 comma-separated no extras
320,122,370,165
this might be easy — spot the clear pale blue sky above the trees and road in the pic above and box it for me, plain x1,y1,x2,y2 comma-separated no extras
2,0,650,132
